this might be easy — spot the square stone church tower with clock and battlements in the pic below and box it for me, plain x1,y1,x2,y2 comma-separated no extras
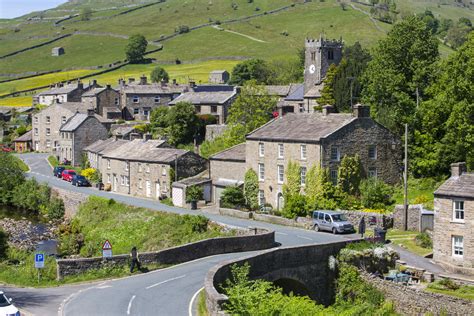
304,35,344,94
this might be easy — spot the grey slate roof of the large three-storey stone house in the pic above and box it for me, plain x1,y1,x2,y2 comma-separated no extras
247,112,357,143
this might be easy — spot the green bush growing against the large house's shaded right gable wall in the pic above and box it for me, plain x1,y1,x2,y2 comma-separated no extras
337,154,362,195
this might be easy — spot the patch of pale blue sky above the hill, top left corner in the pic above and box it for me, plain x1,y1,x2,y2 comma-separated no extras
0,0,66,19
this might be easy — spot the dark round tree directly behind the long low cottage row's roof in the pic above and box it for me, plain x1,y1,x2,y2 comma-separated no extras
168,102,198,145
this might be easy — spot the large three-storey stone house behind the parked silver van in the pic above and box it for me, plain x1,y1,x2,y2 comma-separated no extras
211,105,400,209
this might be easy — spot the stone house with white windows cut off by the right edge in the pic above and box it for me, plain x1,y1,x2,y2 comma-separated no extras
433,162,474,275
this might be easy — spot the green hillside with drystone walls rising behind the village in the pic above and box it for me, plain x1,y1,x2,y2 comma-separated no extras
0,0,474,104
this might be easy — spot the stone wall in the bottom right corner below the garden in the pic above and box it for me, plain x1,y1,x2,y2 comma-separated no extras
361,272,474,316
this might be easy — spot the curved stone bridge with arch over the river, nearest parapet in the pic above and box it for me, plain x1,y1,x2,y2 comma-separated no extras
204,240,358,315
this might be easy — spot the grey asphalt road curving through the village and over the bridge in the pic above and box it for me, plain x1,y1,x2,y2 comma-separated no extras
6,154,357,316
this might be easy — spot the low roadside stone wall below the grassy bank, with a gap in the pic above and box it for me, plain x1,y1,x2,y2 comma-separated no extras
56,228,275,279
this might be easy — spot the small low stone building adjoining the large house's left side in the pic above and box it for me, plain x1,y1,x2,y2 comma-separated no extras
209,143,246,203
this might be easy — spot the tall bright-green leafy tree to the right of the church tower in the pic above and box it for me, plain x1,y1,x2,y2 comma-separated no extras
362,16,439,135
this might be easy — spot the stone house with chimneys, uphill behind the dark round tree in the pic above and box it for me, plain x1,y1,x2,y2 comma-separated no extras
118,76,191,120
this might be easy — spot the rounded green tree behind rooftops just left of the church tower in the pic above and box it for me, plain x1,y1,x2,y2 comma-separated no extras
230,59,270,86
